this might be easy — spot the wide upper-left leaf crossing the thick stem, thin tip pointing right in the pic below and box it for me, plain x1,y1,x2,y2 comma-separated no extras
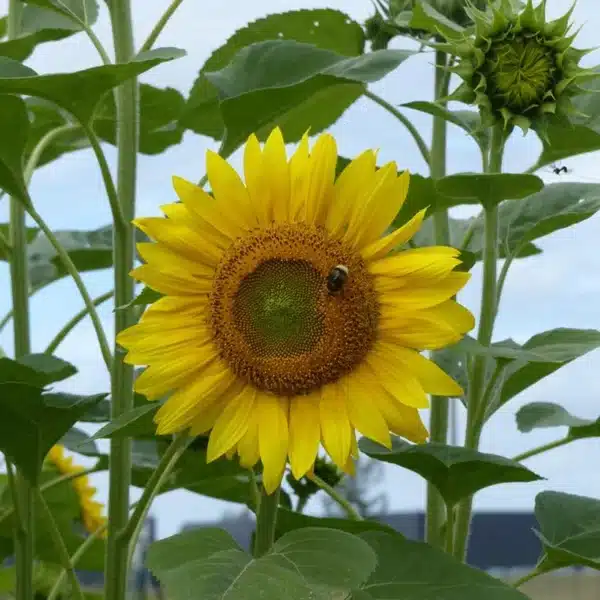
0,48,184,123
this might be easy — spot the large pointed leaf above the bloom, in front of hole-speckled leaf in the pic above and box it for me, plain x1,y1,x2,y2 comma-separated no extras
206,40,414,155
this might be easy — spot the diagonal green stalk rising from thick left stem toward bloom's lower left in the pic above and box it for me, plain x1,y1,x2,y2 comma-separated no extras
119,433,188,564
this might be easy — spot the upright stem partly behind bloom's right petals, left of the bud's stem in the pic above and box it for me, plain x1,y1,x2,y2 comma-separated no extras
425,51,450,548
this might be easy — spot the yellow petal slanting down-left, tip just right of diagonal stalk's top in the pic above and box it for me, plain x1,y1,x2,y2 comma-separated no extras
206,385,256,462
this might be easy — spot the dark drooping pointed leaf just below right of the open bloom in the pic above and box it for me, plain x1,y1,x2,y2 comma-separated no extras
359,438,542,505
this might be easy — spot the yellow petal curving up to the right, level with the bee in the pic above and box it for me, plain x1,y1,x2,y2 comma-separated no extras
374,271,471,311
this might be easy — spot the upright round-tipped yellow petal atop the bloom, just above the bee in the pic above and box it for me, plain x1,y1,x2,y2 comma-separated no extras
305,133,337,225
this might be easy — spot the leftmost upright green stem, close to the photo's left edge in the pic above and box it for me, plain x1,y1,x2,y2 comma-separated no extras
6,0,35,600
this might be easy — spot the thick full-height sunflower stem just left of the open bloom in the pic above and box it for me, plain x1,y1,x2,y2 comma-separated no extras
105,0,139,600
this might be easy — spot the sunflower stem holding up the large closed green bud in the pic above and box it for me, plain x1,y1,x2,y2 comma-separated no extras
454,125,506,560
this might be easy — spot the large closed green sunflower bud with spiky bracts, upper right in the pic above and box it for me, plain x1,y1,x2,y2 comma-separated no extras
448,0,596,136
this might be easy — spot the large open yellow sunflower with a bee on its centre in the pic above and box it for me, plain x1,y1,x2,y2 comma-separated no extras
118,129,474,493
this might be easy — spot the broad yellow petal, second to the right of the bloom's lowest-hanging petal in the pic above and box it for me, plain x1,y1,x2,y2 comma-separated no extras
320,379,351,468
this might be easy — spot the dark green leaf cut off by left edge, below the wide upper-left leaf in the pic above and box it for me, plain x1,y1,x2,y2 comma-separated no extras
0,94,29,203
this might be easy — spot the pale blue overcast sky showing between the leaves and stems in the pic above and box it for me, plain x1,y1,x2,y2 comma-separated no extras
0,0,600,536
